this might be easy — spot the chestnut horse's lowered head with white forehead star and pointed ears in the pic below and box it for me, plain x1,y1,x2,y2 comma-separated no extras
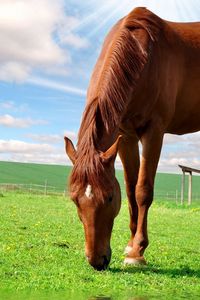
65,137,121,270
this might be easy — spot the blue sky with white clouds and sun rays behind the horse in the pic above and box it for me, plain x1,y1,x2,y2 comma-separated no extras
0,0,200,173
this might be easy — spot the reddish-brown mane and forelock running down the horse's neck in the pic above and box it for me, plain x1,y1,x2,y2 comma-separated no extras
70,8,161,199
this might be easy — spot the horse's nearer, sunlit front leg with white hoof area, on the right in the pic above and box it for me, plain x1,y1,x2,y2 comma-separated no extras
125,126,163,264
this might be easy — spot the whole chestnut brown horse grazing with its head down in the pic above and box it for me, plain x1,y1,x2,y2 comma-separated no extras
65,8,200,270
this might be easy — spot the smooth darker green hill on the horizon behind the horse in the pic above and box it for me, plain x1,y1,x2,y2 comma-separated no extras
0,161,200,197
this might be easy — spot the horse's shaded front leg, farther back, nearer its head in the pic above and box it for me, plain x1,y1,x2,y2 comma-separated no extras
119,136,140,254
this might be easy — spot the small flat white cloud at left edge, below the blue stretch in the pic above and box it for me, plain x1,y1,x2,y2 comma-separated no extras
0,114,47,128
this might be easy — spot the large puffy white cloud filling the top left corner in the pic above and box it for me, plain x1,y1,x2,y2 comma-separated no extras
0,0,87,82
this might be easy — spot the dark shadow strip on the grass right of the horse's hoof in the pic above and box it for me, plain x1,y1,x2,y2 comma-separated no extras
109,265,200,278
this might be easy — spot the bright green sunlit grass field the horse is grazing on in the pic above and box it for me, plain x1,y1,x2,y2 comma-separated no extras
0,193,200,299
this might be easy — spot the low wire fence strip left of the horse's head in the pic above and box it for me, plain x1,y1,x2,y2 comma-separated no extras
0,183,66,195
